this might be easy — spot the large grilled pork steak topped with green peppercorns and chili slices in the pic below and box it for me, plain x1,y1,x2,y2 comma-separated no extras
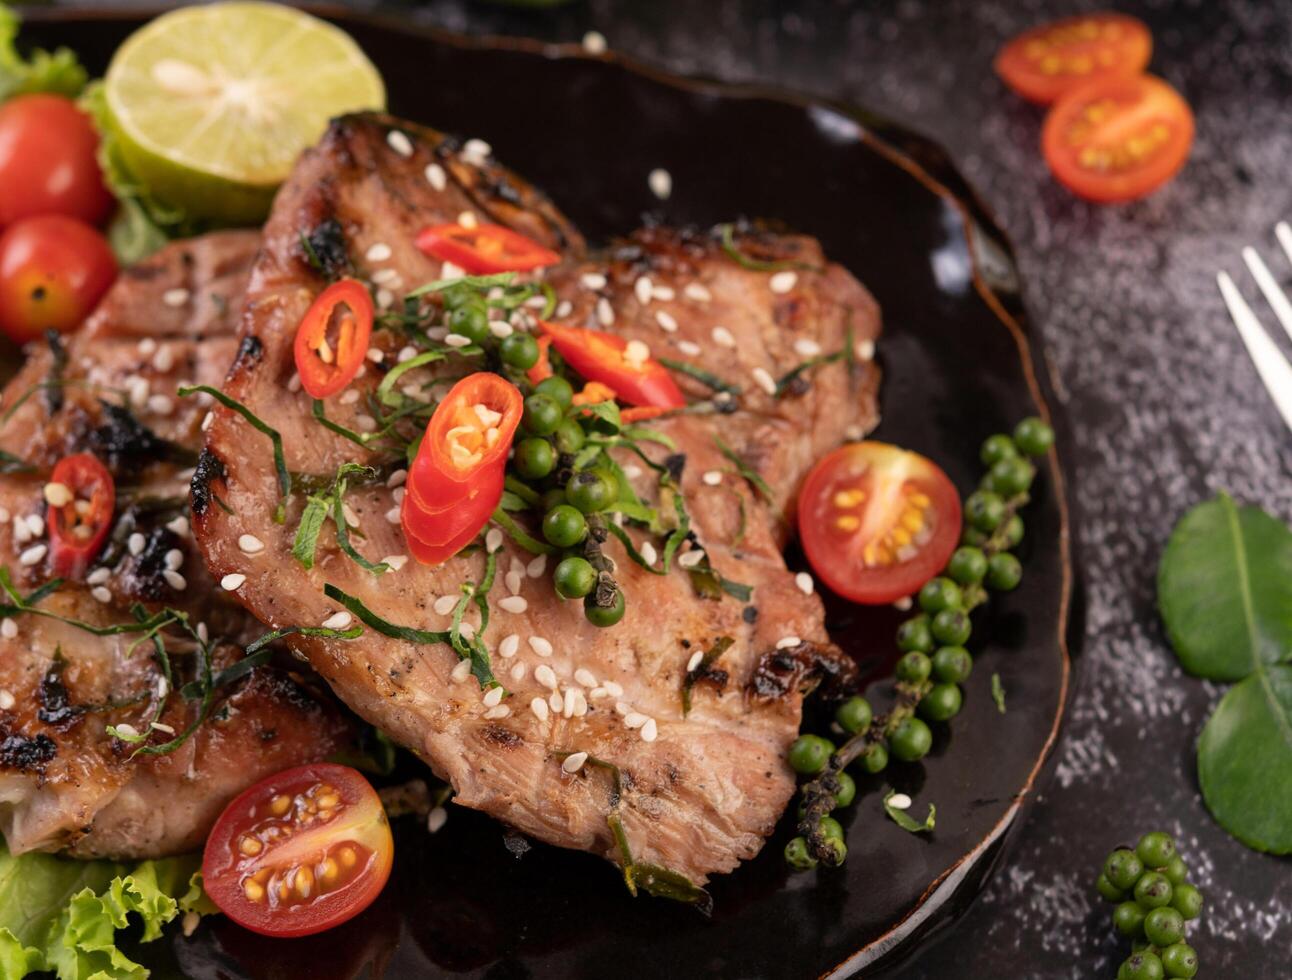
194,115,876,883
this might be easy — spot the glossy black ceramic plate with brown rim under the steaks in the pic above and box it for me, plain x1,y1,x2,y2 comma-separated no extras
25,5,1080,979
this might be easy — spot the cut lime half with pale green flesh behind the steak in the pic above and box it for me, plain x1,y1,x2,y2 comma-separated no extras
106,3,385,225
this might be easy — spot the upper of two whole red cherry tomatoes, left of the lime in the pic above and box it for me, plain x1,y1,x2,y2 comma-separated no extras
0,96,114,227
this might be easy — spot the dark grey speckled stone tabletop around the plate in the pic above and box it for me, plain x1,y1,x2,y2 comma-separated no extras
55,0,1292,980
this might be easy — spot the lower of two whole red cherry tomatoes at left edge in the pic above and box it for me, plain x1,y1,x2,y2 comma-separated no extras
0,214,116,343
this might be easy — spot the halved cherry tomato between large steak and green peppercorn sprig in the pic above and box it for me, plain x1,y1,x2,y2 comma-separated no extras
798,442,960,606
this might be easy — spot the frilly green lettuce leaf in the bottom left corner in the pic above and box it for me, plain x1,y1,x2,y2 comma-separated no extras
0,847,216,980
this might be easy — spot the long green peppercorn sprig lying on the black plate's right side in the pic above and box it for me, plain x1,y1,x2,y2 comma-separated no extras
786,418,1054,870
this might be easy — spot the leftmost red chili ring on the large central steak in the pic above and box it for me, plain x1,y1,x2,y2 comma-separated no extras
295,279,372,398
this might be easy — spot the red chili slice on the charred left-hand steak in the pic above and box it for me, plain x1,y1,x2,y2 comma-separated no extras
45,453,116,578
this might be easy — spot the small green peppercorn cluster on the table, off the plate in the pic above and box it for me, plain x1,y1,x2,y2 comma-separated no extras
1094,830,1203,980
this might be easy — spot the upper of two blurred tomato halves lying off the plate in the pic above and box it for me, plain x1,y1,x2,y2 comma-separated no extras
995,13,1152,105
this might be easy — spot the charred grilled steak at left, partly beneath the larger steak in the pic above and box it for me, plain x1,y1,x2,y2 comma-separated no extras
0,232,348,857
